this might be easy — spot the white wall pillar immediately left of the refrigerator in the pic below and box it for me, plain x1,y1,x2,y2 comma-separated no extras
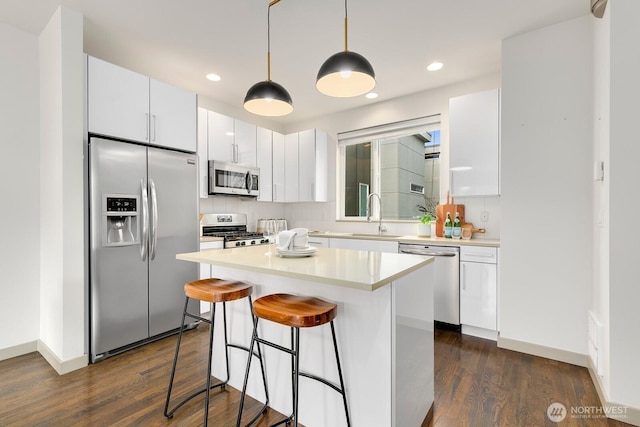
39,7,87,372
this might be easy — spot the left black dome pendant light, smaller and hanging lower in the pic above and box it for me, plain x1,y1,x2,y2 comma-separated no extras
244,0,293,117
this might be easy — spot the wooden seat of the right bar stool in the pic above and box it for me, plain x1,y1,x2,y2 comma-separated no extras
253,294,337,328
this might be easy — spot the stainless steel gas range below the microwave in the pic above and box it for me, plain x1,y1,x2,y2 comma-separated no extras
200,214,269,248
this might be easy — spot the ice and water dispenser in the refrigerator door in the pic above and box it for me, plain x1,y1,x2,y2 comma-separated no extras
102,194,140,246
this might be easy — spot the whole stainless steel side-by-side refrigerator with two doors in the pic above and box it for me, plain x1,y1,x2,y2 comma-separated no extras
88,137,199,362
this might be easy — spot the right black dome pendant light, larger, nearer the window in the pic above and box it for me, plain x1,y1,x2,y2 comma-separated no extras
316,0,376,98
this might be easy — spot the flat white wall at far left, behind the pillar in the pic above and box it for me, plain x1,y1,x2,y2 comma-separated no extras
0,24,40,360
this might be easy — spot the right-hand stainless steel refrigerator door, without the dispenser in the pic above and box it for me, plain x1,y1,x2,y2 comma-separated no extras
148,148,200,336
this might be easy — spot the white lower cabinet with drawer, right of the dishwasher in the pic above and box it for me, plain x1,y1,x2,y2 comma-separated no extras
460,246,498,340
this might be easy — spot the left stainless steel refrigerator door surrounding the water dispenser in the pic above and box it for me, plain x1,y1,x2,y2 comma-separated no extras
89,138,148,361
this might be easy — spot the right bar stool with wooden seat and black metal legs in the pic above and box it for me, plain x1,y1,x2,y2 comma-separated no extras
236,294,351,427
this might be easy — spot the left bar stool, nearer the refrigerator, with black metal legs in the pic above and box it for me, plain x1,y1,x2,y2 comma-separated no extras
164,279,269,427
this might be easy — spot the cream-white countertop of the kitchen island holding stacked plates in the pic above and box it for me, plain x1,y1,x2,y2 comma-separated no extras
176,245,433,291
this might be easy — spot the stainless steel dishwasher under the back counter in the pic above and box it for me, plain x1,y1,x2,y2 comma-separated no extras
398,243,460,331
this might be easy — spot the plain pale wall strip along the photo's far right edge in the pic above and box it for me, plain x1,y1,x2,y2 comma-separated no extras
608,0,640,412
